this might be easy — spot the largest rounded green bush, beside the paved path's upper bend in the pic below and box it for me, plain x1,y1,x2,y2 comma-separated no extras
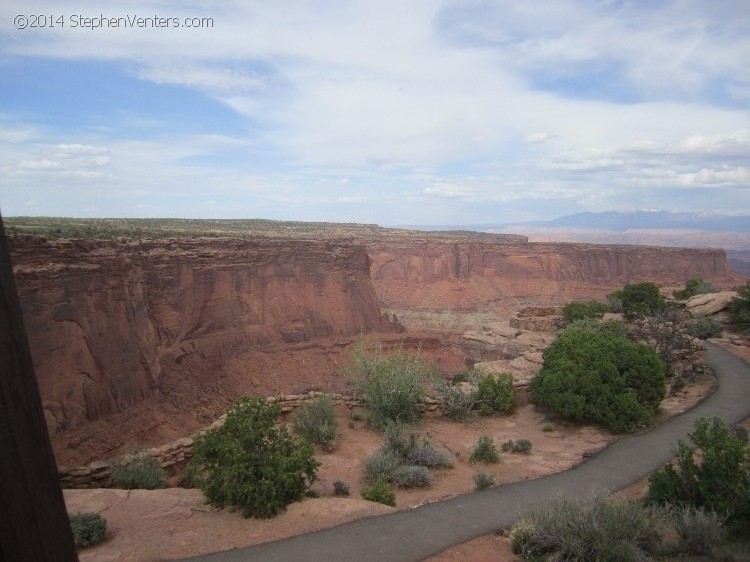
531,328,666,432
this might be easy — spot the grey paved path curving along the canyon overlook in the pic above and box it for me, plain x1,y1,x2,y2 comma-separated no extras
182,344,750,562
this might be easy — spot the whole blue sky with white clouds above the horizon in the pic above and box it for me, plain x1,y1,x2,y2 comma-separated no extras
0,0,750,225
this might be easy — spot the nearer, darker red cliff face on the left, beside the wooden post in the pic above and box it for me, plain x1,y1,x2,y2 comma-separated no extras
11,236,394,433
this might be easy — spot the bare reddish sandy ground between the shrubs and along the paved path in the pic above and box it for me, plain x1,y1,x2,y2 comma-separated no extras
65,370,713,562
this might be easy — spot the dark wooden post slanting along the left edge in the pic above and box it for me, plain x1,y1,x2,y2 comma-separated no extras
0,213,78,562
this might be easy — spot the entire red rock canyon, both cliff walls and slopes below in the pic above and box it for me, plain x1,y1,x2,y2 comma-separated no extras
5,225,740,465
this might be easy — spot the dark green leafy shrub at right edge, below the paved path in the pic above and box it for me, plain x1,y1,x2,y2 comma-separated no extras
646,418,750,536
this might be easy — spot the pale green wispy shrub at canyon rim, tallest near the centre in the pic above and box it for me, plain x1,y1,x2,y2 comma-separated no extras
345,339,431,428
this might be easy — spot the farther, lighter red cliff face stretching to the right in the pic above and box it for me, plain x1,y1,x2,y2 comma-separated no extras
368,241,736,314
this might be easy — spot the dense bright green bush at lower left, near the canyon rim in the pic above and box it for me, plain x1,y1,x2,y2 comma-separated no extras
191,398,319,518
